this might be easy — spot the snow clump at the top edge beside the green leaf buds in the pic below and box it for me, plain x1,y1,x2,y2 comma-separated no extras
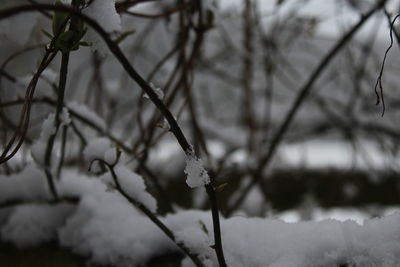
83,0,121,55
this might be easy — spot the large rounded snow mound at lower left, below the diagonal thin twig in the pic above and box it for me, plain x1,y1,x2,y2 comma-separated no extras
59,192,174,267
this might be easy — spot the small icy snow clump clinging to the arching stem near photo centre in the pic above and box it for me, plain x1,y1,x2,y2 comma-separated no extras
185,150,210,188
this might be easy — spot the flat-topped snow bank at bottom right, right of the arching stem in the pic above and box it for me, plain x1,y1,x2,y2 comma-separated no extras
222,214,400,267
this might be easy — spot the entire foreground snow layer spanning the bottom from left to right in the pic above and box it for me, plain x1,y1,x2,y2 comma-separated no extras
0,165,400,267
